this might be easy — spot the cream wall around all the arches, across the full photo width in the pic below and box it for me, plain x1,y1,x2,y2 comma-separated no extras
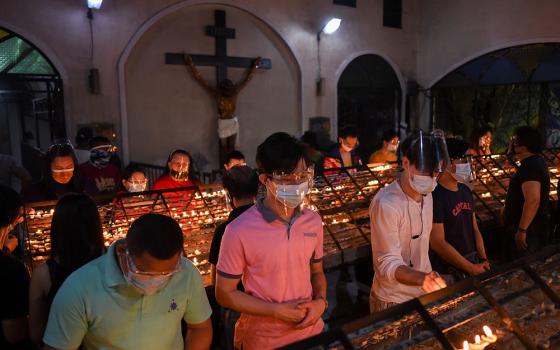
4,0,560,167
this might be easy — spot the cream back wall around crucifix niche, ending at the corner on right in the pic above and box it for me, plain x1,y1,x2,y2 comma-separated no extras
0,0,416,167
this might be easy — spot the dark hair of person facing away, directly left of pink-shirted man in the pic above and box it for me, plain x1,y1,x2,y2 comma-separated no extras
222,165,259,199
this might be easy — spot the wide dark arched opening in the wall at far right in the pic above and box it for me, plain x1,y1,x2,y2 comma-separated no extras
432,43,560,152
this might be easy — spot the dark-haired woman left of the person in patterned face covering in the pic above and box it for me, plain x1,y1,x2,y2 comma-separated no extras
23,142,83,202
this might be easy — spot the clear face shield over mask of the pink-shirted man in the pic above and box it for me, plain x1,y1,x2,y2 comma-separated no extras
270,166,314,209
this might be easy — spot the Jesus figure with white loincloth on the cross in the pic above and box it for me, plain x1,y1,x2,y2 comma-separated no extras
185,55,261,162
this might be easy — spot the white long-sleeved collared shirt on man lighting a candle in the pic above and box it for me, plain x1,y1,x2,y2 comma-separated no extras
369,181,433,303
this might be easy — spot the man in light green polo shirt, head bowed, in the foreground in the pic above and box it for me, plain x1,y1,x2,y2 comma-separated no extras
43,214,212,350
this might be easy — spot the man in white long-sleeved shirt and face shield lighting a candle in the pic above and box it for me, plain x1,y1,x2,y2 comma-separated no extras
369,132,449,312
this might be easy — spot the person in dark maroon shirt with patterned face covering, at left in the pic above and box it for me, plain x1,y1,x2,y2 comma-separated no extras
79,137,121,197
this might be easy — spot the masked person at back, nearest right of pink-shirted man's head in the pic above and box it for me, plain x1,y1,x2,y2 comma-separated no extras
323,126,362,169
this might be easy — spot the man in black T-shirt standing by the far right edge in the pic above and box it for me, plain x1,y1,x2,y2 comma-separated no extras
504,126,550,260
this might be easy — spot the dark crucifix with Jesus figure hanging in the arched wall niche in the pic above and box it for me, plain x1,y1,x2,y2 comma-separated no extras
165,10,272,164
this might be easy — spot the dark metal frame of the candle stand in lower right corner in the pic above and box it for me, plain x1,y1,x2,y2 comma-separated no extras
284,245,560,350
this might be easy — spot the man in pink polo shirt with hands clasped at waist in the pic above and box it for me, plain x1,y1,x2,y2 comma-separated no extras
216,133,328,350
